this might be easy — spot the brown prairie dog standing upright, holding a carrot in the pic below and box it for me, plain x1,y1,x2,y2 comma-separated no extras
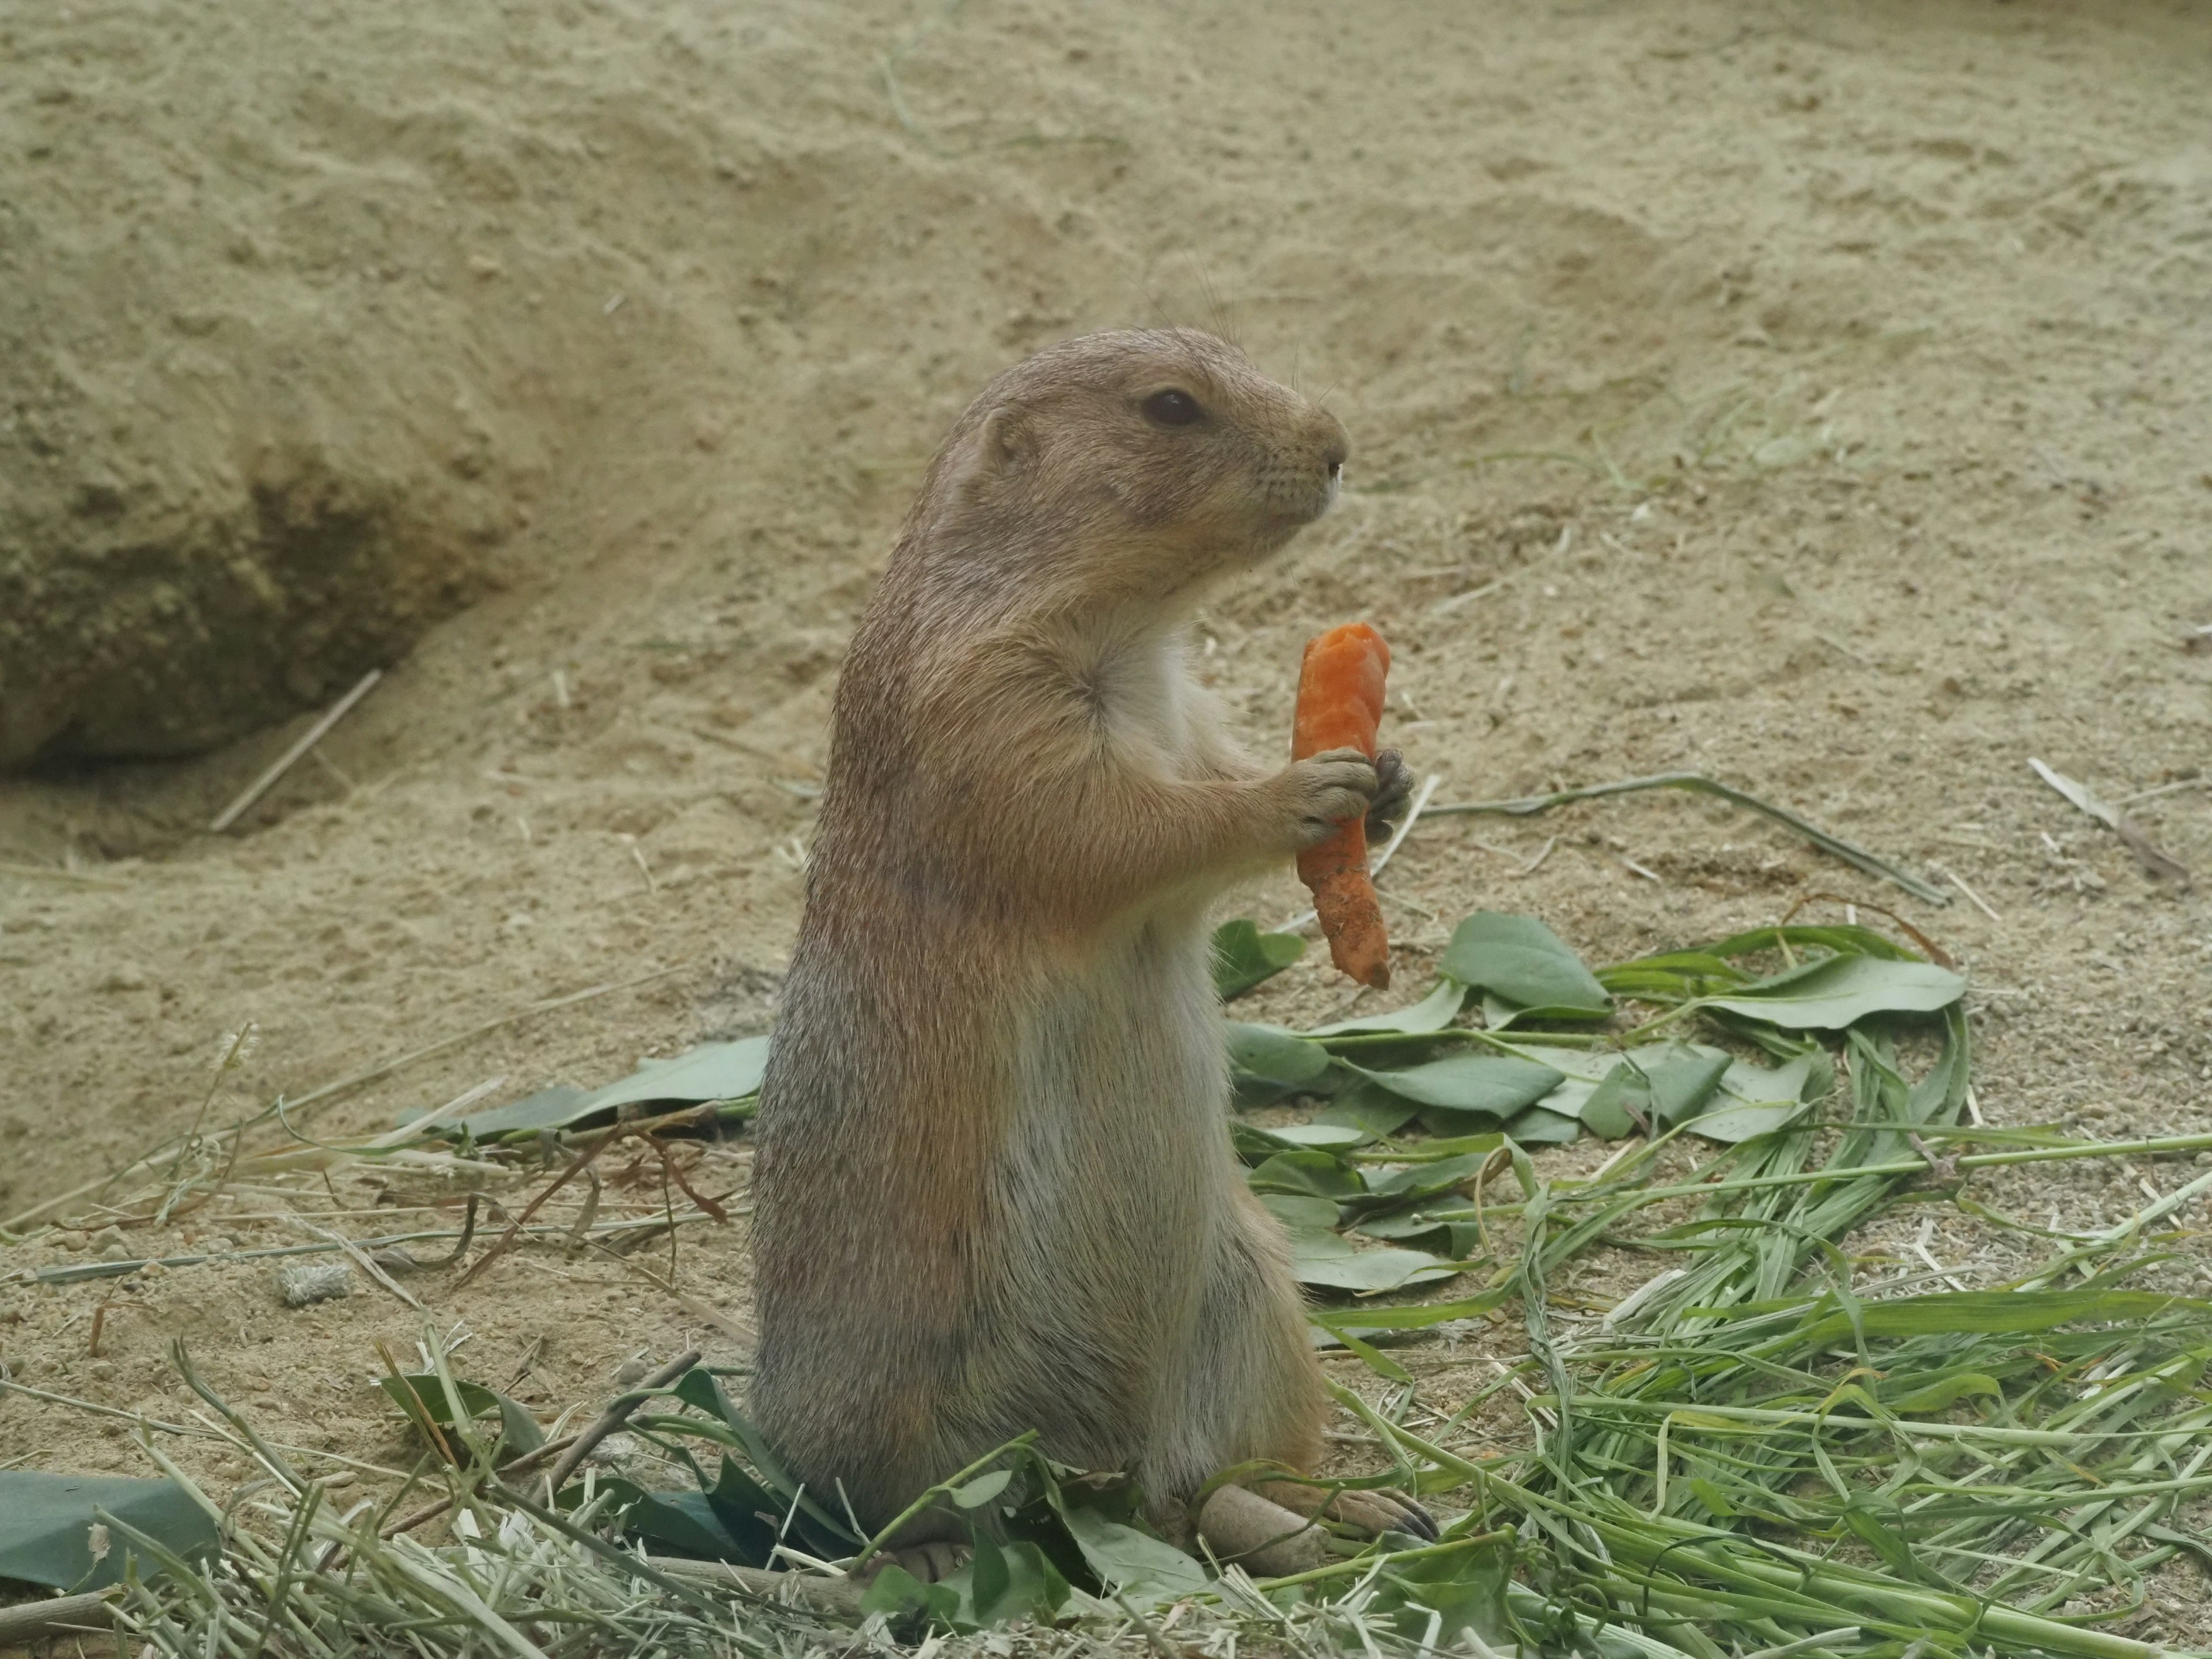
752,329,1433,1575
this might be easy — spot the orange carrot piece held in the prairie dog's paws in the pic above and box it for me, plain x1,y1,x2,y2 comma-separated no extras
1290,622,1389,988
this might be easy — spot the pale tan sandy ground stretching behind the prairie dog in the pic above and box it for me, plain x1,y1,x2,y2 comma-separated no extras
0,0,2212,1637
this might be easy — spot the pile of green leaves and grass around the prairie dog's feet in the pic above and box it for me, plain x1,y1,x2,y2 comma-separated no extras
90,914,2212,1659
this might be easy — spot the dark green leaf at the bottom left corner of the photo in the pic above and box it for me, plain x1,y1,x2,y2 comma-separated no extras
0,1478,219,1590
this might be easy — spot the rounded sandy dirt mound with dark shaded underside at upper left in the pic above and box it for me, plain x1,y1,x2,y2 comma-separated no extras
0,13,544,767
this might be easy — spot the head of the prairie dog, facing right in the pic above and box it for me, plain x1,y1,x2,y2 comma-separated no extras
909,329,1349,608
